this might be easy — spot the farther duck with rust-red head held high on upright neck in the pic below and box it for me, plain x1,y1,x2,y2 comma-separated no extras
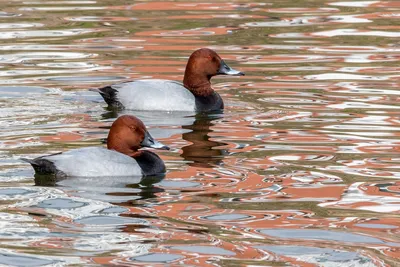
90,48,245,112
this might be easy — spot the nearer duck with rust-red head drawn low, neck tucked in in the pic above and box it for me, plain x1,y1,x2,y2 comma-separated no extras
21,115,169,179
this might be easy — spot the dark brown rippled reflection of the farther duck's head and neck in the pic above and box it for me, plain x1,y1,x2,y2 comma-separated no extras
181,114,227,167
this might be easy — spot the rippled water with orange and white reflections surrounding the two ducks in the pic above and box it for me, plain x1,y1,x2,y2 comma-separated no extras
0,0,400,267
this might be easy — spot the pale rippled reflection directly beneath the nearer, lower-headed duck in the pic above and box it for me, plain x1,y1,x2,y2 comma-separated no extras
35,174,165,204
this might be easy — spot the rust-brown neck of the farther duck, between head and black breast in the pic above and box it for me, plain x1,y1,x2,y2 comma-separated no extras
183,68,214,96
